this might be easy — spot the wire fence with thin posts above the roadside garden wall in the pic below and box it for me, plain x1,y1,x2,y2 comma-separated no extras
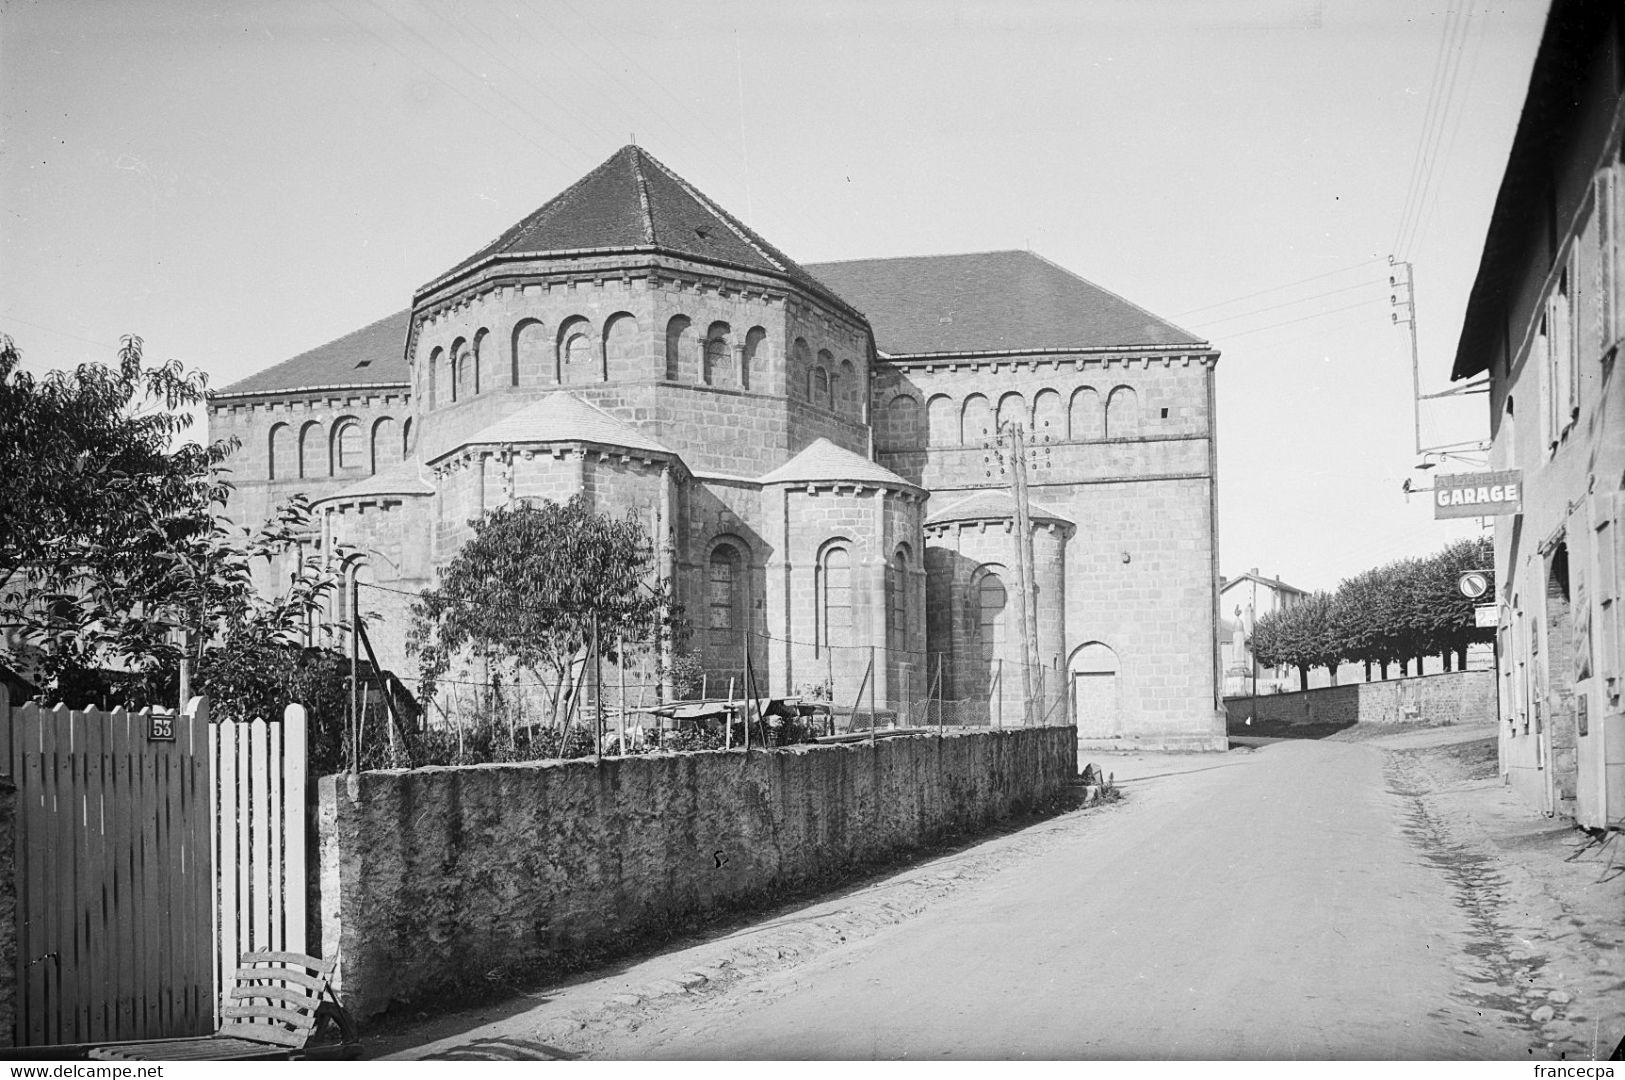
353,583,1073,768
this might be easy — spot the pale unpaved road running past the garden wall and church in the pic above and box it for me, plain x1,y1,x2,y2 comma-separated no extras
386,727,1612,1059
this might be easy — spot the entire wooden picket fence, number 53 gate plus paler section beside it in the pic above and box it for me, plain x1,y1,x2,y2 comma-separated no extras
0,687,306,1046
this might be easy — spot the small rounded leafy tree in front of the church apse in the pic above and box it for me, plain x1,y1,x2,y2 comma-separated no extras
406,495,679,728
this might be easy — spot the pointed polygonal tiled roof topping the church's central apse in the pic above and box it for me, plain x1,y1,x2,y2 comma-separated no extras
419,146,864,313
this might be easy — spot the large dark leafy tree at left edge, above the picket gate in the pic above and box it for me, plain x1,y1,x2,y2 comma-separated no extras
0,335,355,715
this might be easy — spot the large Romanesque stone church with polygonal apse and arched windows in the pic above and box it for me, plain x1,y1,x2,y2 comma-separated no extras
210,146,1225,749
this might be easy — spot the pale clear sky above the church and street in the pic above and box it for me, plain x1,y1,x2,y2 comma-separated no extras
0,0,1547,588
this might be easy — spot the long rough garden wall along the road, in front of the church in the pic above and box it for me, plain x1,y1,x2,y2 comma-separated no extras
319,728,1077,1017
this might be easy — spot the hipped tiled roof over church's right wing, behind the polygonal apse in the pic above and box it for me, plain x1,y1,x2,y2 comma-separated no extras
809,252,1203,356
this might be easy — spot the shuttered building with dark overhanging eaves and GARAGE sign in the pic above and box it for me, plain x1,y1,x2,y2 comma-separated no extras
1451,0,1625,828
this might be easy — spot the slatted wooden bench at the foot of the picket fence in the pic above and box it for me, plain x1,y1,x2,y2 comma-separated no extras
88,952,361,1061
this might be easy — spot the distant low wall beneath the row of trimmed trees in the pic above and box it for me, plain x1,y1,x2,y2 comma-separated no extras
1225,671,1495,734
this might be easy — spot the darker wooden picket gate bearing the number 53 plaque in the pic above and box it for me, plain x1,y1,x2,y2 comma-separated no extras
0,687,215,1046
